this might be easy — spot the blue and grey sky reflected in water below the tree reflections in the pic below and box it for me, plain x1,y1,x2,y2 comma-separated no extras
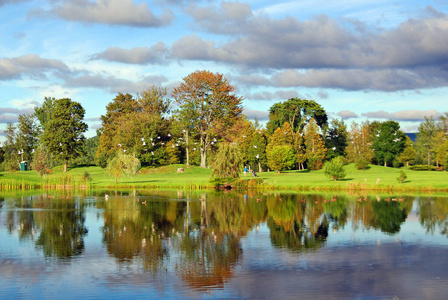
0,197,448,299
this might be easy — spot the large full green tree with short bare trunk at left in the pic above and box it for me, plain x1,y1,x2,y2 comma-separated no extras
41,98,88,172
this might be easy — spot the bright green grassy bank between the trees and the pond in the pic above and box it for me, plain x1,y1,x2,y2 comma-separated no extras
0,164,448,192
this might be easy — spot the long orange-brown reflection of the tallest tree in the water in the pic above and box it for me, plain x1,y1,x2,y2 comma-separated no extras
179,197,243,290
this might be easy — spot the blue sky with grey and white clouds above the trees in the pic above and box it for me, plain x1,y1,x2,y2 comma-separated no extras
0,0,448,141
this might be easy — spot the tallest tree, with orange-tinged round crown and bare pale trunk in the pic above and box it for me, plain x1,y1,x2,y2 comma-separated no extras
172,71,242,168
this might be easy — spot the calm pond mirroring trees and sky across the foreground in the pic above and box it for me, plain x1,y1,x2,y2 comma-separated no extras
0,190,448,299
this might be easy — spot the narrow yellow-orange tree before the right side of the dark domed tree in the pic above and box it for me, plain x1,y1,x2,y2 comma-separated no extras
304,119,327,170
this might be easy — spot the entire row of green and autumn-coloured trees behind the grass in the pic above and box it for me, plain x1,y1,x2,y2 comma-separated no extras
0,71,448,178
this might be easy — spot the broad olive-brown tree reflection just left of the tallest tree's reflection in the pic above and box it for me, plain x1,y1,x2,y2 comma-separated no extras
103,197,185,273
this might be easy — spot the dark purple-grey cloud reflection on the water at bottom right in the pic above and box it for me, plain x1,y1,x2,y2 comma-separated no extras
233,244,448,299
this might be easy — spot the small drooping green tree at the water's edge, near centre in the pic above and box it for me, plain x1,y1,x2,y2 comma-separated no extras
212,143,243,178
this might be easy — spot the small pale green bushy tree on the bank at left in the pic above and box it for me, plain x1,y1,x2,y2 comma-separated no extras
106,151,140,183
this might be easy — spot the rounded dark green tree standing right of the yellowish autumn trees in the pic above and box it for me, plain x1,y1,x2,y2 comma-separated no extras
372,121,406,167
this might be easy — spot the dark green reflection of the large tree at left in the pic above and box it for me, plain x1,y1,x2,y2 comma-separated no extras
36,200,87,258
